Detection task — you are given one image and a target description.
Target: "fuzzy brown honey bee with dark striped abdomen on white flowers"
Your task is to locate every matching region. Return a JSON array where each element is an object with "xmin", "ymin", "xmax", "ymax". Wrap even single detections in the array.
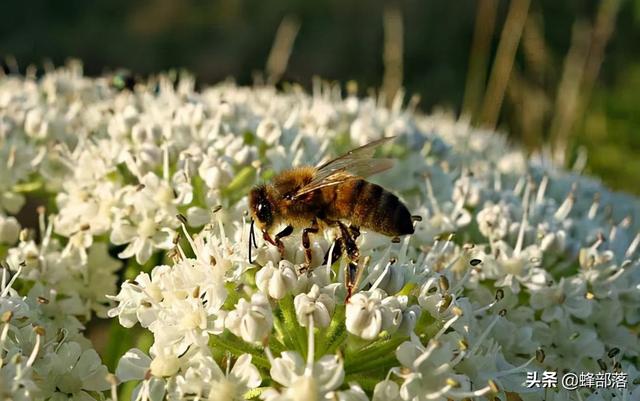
[{"xmin": 249, "ymin": 137, "xmax": 417, "ymax": 266}]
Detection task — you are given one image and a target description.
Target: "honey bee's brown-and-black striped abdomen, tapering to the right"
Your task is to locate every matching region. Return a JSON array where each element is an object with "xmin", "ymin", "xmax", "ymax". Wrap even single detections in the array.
[{"xmin": 323, "ymin": 179, "xmax": 413, "ymax": 237}]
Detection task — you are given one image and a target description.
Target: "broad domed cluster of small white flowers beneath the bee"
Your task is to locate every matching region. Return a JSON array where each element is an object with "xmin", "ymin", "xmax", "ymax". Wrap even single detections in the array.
[{"xmin": 0, "ymin": 64, "xmax": 640, "ymax": 401}]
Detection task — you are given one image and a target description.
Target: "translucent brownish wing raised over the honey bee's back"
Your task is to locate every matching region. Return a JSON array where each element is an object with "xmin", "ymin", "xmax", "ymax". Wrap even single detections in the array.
[{"xmin": 294, "ymin": 136, "xmax": 395, "ymax": 197}]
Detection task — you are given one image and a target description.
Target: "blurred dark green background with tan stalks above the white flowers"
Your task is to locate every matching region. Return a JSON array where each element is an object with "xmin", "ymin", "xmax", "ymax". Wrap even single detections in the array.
[{"xmin": 0, "ymin": 0, "xmax": 640, "ymax": 194}]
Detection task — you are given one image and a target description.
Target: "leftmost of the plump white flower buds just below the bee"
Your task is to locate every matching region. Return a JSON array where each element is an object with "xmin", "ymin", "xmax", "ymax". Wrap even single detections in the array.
[{"xmin": 225, "ymin": 293, "xmax": 273, "ymax": 342}]
